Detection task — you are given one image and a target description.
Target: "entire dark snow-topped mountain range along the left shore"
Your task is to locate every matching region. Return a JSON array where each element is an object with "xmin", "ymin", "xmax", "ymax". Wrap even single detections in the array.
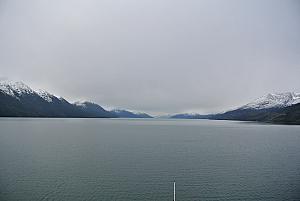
[{"xmin": 0, "ymin": 81, "xmax": 151, "ymax": 118}]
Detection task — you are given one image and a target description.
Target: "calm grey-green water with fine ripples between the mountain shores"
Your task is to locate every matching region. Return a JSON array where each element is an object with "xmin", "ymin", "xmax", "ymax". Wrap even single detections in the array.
[{"xmin": 0, "ymin": 118, "xmax": 300, "ymax": 201}]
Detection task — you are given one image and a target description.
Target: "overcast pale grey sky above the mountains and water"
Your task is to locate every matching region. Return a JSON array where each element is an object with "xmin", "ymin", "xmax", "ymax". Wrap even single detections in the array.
[{"xmin": 0, "ymin": 0, "xmax": 300, "ymax": 114}]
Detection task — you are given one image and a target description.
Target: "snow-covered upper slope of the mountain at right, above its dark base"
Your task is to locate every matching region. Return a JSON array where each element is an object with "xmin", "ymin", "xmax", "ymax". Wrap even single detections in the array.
[{"xmin": 240, "ymin": 92, "xmax": 300, "ymax": 110}]
